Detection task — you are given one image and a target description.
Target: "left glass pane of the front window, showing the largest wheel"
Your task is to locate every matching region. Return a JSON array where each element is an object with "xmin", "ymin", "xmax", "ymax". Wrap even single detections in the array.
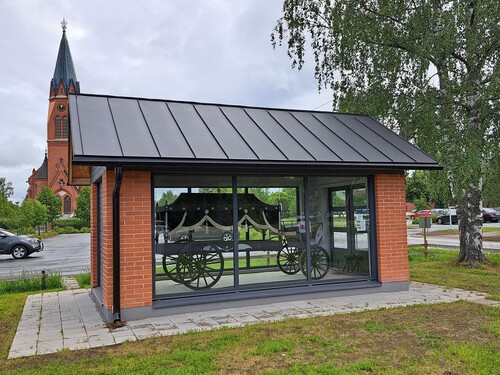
[{"xmin": 153, "ymin": 176, "xmax": 234, "ymax": 295}]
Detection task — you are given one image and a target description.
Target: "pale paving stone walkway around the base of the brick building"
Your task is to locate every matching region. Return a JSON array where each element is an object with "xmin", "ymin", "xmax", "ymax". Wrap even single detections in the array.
[{"xmin": 9, "ymin": 283, "xmax": 500, "ymax": 358}]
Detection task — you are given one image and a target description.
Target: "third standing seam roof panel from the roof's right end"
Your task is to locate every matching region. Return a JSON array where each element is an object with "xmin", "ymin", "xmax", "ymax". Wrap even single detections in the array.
[{"xmin": 314, "ymin": 113, "xmax": 392, "ymax": 163}]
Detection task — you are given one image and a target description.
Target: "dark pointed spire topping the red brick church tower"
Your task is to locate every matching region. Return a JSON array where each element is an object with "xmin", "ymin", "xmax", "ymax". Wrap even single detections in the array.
[{"xmin": 50, "ymin": 19, "xmax": 80, "ymax": 97}]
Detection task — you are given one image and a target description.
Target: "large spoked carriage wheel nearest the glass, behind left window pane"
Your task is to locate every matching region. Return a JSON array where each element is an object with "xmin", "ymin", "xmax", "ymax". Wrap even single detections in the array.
[{"xmin": 176, "ymin": 242, "xmax": 224, "ymax": 290}]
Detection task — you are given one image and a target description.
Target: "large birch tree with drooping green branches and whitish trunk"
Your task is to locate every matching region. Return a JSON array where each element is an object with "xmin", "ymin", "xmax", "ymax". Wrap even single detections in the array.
[{"xmin": 272, "ymin": 0, "xmax": 500, "ymax": 265}]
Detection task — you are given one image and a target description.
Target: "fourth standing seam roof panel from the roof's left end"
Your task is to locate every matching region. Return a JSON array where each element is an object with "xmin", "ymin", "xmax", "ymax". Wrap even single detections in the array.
[{"xmin": 168, "ymin": 103, "xmax": 227, "ymax": 159}]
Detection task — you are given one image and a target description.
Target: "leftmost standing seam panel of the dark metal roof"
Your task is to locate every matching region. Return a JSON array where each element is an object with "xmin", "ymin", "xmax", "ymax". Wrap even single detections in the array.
[{"xmin": 70, "ymin": 96, "xmax": 123, "ymax": 156}]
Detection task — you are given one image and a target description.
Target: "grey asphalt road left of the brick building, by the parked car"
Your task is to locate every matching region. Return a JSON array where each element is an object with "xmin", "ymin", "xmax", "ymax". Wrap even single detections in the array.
[{"xmin": 0, "ymin": 233, "xmax": 90, "ymax": 280}]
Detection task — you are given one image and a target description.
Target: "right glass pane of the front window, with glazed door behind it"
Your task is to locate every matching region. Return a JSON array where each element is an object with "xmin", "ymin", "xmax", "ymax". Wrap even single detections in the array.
[{"xmin": 309, "ymin": 177, "xmax": 370, "ymax": 280}]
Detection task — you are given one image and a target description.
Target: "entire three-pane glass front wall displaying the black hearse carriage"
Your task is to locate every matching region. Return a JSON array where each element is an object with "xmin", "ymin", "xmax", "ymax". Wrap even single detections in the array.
[{"xmin": 153, "ymin": 175, "xmax": 371, "ymax": 298}]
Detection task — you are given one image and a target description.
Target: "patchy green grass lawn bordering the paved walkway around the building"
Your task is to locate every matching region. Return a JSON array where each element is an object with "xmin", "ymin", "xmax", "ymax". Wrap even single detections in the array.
[{"xmin": 0, "ymin": 249, "xmax": 500, "ymax": 375}]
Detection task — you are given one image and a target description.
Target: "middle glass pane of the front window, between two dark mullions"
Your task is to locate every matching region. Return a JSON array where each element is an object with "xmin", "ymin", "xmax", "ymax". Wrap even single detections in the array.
[{"xmin": 238, "ymin": 177, "xmax": 306, "ymax": 286}]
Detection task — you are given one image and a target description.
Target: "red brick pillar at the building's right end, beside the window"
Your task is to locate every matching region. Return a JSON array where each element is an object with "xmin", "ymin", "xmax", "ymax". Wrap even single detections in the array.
[{"xmin": 375, "ymin": 174, "xmax": 409, "ymax": 282}]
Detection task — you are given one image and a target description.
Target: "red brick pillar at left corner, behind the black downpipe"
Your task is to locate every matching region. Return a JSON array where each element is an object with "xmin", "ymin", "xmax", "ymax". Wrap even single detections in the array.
[{"xmin": 91, "ymin": 169, "xmax": 153, "ymax": 313}]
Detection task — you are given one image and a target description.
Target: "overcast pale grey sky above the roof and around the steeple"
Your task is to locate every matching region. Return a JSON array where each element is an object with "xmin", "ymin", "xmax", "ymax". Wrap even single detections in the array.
[{"xmin": 0, "ymin": 0, "xmax": 331, "ymax": 201}]
